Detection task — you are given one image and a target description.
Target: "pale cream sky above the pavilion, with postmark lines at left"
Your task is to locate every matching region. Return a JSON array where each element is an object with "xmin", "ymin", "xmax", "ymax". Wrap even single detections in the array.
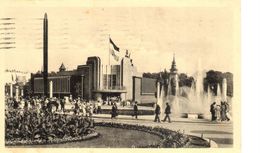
[{"xmin": 0, "ymin": 7, "xmax": 238, "ymax": 75}]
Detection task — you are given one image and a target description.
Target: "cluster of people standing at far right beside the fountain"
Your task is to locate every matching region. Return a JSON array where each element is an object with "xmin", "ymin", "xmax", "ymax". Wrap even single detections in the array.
[{"xmin": 210, "ymin": 101, "xmax": 230, "ymax": 122}]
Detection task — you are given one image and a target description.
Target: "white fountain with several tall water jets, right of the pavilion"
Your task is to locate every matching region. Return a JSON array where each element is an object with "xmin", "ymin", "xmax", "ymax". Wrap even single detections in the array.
[{"xmin": 157, "ymin": 57, "xmax": 232, "ymax": 119}]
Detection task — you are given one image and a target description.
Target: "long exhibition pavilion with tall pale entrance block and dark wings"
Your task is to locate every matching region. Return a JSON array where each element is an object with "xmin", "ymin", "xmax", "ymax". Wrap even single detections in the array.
[{"xmin": 31, "ymin": 57, "xmax": 156, "ymax": 103}]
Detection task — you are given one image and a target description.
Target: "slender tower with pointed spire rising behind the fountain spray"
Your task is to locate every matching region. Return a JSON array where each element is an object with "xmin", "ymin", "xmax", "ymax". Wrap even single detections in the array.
[{"xmin": 168, "ymin": 54, "xmax": 179, "ymax": 96}]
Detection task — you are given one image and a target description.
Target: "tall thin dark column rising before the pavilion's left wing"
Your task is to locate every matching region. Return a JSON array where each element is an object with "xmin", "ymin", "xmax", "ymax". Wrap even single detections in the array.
[{"xmin": 43, "ymin": 13, "xmax": 48, "ymax": 97}]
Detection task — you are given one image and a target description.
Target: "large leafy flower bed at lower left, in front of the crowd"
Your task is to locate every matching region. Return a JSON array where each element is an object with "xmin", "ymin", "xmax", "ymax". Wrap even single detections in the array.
[{"xmin": 5, "ymin": 109, "xmax": 99, "ymax": 146}]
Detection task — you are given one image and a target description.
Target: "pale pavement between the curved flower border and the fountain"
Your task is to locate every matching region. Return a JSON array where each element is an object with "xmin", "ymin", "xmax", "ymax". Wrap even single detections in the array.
[{"xmin": 93, "ymin": 114, "xmax": 233, "ymax": 148}]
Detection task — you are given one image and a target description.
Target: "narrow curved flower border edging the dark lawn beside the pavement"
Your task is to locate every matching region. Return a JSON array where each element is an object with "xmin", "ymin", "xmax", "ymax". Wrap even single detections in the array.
[{"xmin": 95, "ymin": 122, "xmax": 209, "ymax": 148}]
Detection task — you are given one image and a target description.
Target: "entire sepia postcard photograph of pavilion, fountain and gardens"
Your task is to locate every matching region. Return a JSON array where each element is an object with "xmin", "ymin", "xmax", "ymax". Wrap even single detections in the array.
[{"xmin": 0, "ymin": 1, "xmax": 240, "ymax": 151}]
